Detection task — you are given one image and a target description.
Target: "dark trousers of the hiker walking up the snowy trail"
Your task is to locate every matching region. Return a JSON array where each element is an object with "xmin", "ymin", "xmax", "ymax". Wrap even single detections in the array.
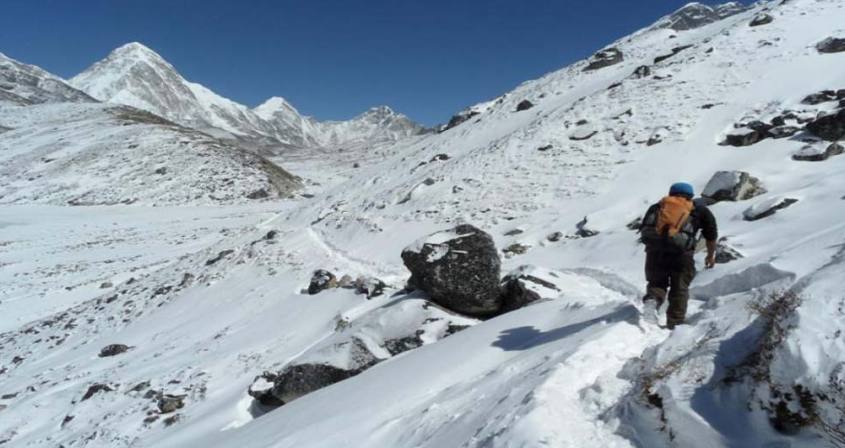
[{"xmin": 644, "ymin": 251, "xmax": 695, "ymax": 327}]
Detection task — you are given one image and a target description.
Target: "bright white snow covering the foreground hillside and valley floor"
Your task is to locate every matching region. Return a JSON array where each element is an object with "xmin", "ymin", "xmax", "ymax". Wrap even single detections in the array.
[{"xmin": 0, "ymin": 0, "xmax": 845, "ymax": 448}]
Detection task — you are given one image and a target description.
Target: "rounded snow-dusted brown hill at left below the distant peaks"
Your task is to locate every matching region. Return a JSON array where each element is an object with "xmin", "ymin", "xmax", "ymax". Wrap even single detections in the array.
[{"xmin": 0, "ymin": 103, "xmax": 299, "ymax": 205}]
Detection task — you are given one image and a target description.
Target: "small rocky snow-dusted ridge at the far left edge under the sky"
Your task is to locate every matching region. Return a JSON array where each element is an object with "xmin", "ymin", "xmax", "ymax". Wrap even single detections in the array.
[{"xmin": 0, "ymin": 53, "xmax": 94, "ymax": 105}]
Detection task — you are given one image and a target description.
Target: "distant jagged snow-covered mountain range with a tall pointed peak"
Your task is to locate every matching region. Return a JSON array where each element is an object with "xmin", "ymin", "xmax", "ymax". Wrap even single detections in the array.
[{"xmin": 70, "ymin": 42, "xmax": 422, "ymax": 147}]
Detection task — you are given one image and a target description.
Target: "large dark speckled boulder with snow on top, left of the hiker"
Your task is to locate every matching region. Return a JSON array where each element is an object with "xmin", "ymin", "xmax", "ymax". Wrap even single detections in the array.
[{"xmin": 402, "ymin": 224, "xmax": 502, "ymax": 317}]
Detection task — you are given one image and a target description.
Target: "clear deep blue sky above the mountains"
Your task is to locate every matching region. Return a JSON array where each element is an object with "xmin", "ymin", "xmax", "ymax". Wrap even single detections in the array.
[{"xmin": 0, "ymin": 0, "xmax": 732, "ymax": 125}]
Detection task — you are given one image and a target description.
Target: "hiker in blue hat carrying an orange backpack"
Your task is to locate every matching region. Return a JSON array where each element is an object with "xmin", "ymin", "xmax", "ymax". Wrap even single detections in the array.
[{"xmin": 640, "ymin": 182, "xmax": 719, "ymax": 330}]
